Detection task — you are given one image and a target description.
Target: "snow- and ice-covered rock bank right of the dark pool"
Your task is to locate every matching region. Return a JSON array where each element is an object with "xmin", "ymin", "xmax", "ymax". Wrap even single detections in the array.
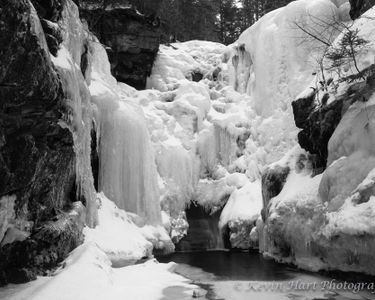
[{"xmin": 256, "ymin": 4, "xmax": 375, "ymax": 274}]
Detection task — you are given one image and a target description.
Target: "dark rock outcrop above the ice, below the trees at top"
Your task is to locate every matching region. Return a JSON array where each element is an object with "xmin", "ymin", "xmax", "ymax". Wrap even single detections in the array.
[{"xmin": 80, "ymin": 1, "xmax": 161, "ymax": 90}]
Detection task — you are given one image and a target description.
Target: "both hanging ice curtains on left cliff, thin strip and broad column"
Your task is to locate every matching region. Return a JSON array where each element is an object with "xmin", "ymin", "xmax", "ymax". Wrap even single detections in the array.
[{"xmin": 52, "ymin": 1, "xmax": 161, "ymax": 225}]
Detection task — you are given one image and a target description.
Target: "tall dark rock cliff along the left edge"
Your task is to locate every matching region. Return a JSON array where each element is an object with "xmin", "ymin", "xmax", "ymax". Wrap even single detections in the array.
[{"xmin": 0, "ymin": 0, "xmax": 89, "ymax": 285}]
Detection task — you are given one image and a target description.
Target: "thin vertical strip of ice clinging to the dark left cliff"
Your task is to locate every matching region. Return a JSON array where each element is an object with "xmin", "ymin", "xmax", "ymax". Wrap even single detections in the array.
[{"xmin": 51, "ymin": 1, "xmax": 97, "ymax": 226}]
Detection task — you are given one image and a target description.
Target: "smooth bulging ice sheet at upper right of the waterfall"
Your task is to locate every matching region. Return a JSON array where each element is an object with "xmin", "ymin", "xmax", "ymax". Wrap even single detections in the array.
[{"xmin": 228, "ymin": 0, "xmax": 350, "ymax": 117}]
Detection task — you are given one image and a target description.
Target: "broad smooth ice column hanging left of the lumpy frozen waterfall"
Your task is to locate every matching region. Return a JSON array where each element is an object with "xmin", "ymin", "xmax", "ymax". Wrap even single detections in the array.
[{"xmin": 90, "ymin": 42, "xmax": 161, "ymax": 225}]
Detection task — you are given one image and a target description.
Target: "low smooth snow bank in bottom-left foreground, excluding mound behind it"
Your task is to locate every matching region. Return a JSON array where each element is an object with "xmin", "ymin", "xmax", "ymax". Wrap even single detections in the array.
[{"xmin": 0, "ymin": 243, "xmax": 196, "ymax": 300}]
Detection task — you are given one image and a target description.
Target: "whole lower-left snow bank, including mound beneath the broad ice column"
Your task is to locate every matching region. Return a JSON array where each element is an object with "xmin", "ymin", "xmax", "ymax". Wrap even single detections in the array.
[{"xmin": 0, "ymin": 193, "xmax": 187, "ymax": 300}]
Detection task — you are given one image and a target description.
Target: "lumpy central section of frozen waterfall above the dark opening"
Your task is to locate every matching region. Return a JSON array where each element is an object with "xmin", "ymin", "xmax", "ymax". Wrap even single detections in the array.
[{"xmin": 145, "ymin": 41, "xmax": 272, "ymax": 231}]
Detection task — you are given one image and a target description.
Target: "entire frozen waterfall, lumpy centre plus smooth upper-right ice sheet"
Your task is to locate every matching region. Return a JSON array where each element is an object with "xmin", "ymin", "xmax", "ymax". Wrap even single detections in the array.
[{"xmin": 135, "ymin": 0, "xmax": 348, "ymax": 241}]
